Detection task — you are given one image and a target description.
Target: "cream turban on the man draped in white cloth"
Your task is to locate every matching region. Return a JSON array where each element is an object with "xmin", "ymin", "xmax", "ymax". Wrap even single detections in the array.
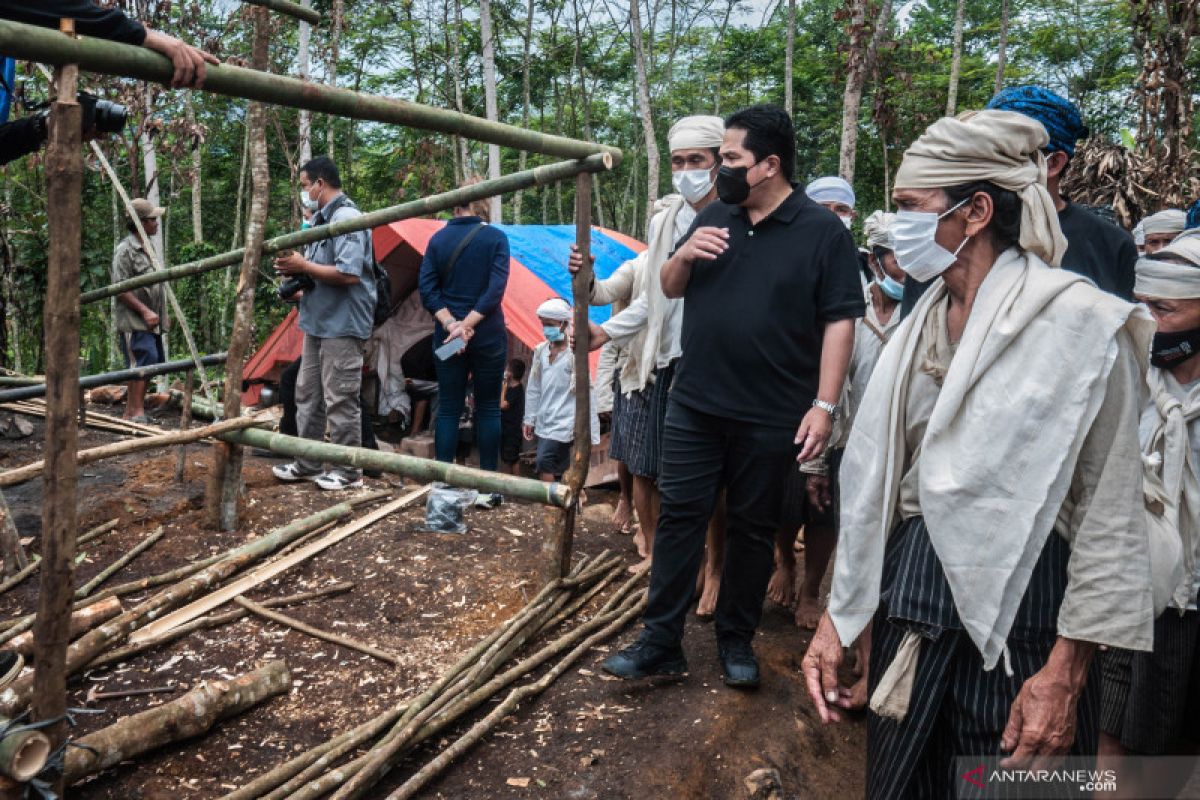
[{"xmin": 895, "ymin": 110, "xmax": 1067, "ymax": 266}]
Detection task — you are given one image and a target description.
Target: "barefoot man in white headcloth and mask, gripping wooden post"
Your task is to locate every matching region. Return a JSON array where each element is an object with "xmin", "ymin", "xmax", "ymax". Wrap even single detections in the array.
[{"xmin": 568, "ymin": 116, "xmax": 725, "ymax": 571}]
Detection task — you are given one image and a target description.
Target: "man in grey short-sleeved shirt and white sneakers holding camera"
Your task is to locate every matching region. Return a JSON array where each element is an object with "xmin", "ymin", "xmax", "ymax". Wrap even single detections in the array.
[{"xmin": 272, "ymin": 156, "xmax": 376, "ymax": 489}]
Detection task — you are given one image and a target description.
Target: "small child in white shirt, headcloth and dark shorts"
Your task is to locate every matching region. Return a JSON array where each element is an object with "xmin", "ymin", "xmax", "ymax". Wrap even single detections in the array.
[{"xmin": 522, "ymin": 297, "xmax": 600, "ymax": 481}]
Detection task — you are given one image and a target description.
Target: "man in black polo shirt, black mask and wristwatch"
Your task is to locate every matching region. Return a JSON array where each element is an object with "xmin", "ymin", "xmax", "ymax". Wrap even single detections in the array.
[{"xmin": 604, "ymin": 106, "xmax": 865, "ymax": 687}]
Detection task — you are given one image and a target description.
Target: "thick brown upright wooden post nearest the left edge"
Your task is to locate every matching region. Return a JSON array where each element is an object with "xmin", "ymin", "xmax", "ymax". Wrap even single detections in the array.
[{"xmin": 32, "ymin": 19, "xmax": 83, "ymax": 796}]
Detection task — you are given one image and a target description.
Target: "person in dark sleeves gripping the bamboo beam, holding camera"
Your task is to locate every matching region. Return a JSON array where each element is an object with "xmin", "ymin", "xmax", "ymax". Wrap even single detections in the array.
[{"xmin": 0, "ymin": 0, "xmax": 217, "ymax": 164}]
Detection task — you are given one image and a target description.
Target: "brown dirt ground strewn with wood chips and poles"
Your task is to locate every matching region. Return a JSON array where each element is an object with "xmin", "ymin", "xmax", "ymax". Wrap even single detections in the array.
[{"xmin": 0, "ymin": 408, "xmax": 865, "ymax": 800}]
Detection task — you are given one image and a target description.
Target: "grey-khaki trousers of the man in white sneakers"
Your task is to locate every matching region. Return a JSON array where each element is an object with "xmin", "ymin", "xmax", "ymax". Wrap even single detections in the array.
[{"xmin": 296, "ymin": 333, "xmax": 366, "ymax": 480}]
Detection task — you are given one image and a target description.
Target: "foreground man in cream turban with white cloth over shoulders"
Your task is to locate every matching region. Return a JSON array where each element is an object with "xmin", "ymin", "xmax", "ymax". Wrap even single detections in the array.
[{"xmin": 803, "ymin": 110, "xmax": 1153, "ymax": 798}]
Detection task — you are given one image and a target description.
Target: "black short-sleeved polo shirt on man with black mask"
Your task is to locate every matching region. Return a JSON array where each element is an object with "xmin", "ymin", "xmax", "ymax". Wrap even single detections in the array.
[{"xmin": 671, "ymin": 188, "xmax": 866, "ymax": 428}]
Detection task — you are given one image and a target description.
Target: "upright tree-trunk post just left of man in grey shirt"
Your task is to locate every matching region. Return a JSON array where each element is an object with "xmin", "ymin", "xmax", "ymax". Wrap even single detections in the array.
[{"xmin": 206, "ymin": 8, "xmax": 271, "ymax": 530}]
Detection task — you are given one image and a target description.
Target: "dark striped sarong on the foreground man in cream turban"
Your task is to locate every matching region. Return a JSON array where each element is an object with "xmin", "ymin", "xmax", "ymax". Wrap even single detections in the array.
[{"xmin": 866, "ymin": 517, "xmax": 1098, "ymax": 800}]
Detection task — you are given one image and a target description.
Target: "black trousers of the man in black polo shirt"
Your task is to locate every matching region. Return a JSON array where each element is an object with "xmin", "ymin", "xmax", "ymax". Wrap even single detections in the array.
[{"xmin": 642, "ymin": 398, "xmax": 797, "ymax": 645}]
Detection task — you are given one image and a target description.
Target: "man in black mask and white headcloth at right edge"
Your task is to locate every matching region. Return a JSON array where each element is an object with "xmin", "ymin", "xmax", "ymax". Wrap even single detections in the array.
[{"xmin": 1100, "ymin": 230, "xmax": 1200, "ymax": 798}]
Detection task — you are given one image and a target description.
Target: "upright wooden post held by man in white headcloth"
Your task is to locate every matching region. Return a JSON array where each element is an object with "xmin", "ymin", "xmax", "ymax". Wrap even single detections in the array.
[{"xmin": 544, "ymin": 173, "xmax": 592, "ymax": 579}]
